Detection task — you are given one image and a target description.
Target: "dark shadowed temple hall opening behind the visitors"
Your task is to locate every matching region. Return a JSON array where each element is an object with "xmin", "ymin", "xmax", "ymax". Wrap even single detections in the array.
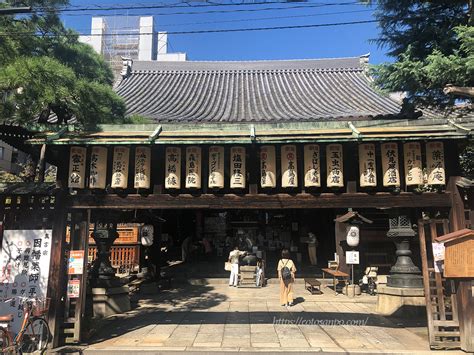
[{"xmin": 156, "ymin": 209, "xmax": 395, "ymax": 278}]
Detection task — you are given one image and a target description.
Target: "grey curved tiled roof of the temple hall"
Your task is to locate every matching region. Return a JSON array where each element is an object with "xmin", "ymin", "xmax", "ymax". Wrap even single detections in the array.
[{"xmin": 116, "ymin": 57, "xmax": 408, "ymax": 123}]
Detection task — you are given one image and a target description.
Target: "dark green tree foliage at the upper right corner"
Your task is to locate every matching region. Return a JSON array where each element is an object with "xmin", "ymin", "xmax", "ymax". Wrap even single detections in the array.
[{"xmin": 372, "ymin": 0, "xmax": 474, "ymax": 108}]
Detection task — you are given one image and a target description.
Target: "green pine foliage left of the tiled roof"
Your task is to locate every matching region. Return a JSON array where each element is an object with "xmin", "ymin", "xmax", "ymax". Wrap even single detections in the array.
[{"xmin": 0, "ymin": 0, "xmax": 125, "ymax": 127}]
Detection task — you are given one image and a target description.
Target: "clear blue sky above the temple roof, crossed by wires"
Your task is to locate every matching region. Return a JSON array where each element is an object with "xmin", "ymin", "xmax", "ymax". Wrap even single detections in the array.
[{"xmin": 62, "ymin": 0, "xmax": 390, "ymax": 64}]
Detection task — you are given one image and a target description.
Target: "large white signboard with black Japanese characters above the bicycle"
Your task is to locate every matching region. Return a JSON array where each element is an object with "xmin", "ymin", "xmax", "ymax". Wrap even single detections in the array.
[{"xmin": 0, "ymin": 230, "xmax": 52, "ymax": 333}]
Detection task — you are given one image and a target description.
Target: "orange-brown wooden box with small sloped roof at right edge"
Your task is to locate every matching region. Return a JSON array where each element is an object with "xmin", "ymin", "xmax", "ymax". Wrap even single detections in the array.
[{"xmin": 435, "ymin": 229, "xmax": 474, "ymax": 278}]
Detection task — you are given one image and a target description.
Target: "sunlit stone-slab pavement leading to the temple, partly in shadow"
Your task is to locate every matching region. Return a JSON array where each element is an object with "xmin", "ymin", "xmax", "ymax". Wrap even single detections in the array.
[{"xmin": 78, "ymin": 284, "xmax": 453, "ymax": 355}]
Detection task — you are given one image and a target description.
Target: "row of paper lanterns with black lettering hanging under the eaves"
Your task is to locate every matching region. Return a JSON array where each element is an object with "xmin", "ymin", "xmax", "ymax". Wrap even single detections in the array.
[{"xmin": 69, "ymin": 142, "xmax": 446, "ymax": 189}]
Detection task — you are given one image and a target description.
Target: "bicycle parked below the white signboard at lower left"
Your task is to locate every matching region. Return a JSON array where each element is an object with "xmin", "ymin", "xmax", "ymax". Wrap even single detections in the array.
[{"xmin": 0, "ymin": 297, "xmax": 50, "ymax": 354}]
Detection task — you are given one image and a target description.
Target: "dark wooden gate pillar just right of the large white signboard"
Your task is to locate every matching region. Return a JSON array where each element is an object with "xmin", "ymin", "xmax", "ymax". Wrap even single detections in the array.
[{"xmin": 47, "ymin": 192, "xmax": 67, "ymax": 348}]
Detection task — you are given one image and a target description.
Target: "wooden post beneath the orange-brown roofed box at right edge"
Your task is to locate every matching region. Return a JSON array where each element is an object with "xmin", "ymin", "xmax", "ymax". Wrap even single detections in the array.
[{"xmin": 456, "ymin": 279, "xmax": 474, "ymax": 353}]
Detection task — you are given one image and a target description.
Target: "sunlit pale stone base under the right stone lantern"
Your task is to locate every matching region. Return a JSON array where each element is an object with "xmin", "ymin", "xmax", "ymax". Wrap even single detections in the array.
[{"xmin": 375, "ymin": 285, "xmax": 426, "ymax": 317}]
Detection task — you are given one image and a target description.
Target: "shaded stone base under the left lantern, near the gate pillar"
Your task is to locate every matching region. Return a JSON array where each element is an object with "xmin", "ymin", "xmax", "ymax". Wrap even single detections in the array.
[{"xmin": 92, "ymin": 286, "xmax": 131, "ymax": 318}]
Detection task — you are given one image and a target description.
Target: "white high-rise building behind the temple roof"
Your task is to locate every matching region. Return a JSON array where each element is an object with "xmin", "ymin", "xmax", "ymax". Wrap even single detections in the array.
[{"xmin": 79, "ymin": 16, "xmax": 186, "ymax": 73}]
